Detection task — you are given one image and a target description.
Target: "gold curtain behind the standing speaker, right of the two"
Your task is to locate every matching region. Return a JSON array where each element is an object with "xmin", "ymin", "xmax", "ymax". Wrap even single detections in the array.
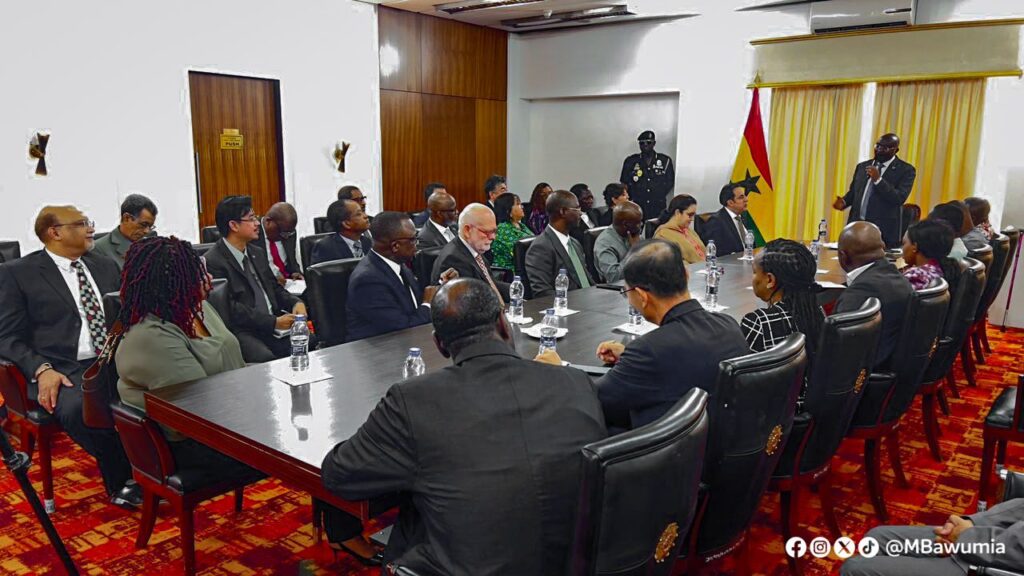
[{"xmin": 873, "ymin": 78, "xmax": 986, "ymax": 215}]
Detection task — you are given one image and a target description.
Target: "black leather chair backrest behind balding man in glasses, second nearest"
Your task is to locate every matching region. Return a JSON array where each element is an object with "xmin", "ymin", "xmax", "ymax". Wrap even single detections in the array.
[{"xmin": 694, "ymin": 332, "xmax": 807, "ymax": 554}]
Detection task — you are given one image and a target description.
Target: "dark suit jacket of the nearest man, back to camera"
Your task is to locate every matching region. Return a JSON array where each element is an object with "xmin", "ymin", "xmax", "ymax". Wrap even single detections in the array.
[{"xmin": 322, "ymin": 340, "xmax": 606, "ymax": 576}]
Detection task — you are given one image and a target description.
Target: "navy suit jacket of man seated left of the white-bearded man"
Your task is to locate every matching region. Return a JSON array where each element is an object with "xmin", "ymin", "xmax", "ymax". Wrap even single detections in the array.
[{"xmin": 345, "ymin": 252, "xmax": 430, "ymax": 342}]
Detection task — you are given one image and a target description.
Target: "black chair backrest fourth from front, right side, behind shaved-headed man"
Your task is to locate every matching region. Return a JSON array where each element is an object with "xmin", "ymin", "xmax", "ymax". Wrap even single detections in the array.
[{"xmin": 881, "ymin": 279, "xmax": 950, "ymax": 422}]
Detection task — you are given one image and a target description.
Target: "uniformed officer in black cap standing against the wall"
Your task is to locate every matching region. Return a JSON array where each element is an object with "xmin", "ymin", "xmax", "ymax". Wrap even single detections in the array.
[{"xmin": 618, "ymin": 130, "xmax": 676, "ymax": 219}]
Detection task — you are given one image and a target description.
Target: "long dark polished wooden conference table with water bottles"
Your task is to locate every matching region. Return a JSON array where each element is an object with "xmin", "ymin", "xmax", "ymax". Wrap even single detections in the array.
[{"xmin": 145, "ymin": 250, "xmax": 846, "ymax": 520}]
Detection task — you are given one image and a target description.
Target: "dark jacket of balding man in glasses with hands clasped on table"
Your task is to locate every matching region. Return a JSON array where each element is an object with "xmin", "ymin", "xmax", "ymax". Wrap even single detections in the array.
[{"xmin": 597, "ymin": 299, "xmax": 751, "ymax": 427}]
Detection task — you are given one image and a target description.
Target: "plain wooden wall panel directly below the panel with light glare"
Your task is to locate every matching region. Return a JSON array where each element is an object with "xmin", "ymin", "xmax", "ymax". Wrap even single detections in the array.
[{"xmin": 381, "ymin": 90, "xmax": 425, "ymax": 210}]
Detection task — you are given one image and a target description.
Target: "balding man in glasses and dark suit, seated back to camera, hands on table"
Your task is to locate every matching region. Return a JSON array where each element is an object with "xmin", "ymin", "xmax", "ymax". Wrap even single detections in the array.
[{"xmin": 539, "ymin": 240, "xmax": 751, "ymax": 428}]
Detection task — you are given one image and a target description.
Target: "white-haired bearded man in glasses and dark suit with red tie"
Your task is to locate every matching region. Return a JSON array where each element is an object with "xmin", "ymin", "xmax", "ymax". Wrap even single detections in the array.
[{"xmin": 430, "ymin": 202, "xmax": 509, "ymax": 304}]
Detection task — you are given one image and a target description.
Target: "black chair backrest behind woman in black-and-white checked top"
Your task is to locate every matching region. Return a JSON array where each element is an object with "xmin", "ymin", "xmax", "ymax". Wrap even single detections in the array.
[{"xmin": 794, "ymin": 298, "xmax": 882, "ymax": 474}]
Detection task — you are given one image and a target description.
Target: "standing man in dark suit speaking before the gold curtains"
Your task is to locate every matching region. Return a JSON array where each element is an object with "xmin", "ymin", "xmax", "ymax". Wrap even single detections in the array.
[{"xmin": 833, "ymin": 134, "xmax": 918, "ymax": 248}]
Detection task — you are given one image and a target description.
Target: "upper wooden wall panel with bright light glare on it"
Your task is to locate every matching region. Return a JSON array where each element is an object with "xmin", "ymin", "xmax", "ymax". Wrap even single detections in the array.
[{"xmin": 377, "ymin": 6, "xmax": 423, "ymax": 92}]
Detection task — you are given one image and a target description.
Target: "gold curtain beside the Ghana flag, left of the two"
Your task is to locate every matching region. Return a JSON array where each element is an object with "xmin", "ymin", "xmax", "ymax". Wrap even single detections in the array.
[{"xmin": 766, "ymin": 84, "xmax": 864, "ymax": 241}]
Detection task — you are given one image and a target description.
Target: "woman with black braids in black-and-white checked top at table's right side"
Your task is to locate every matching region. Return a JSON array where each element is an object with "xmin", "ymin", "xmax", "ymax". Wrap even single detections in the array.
[{"xmin": 740, "ymin": 239, "xmax": 824, "ymax": 359}]
